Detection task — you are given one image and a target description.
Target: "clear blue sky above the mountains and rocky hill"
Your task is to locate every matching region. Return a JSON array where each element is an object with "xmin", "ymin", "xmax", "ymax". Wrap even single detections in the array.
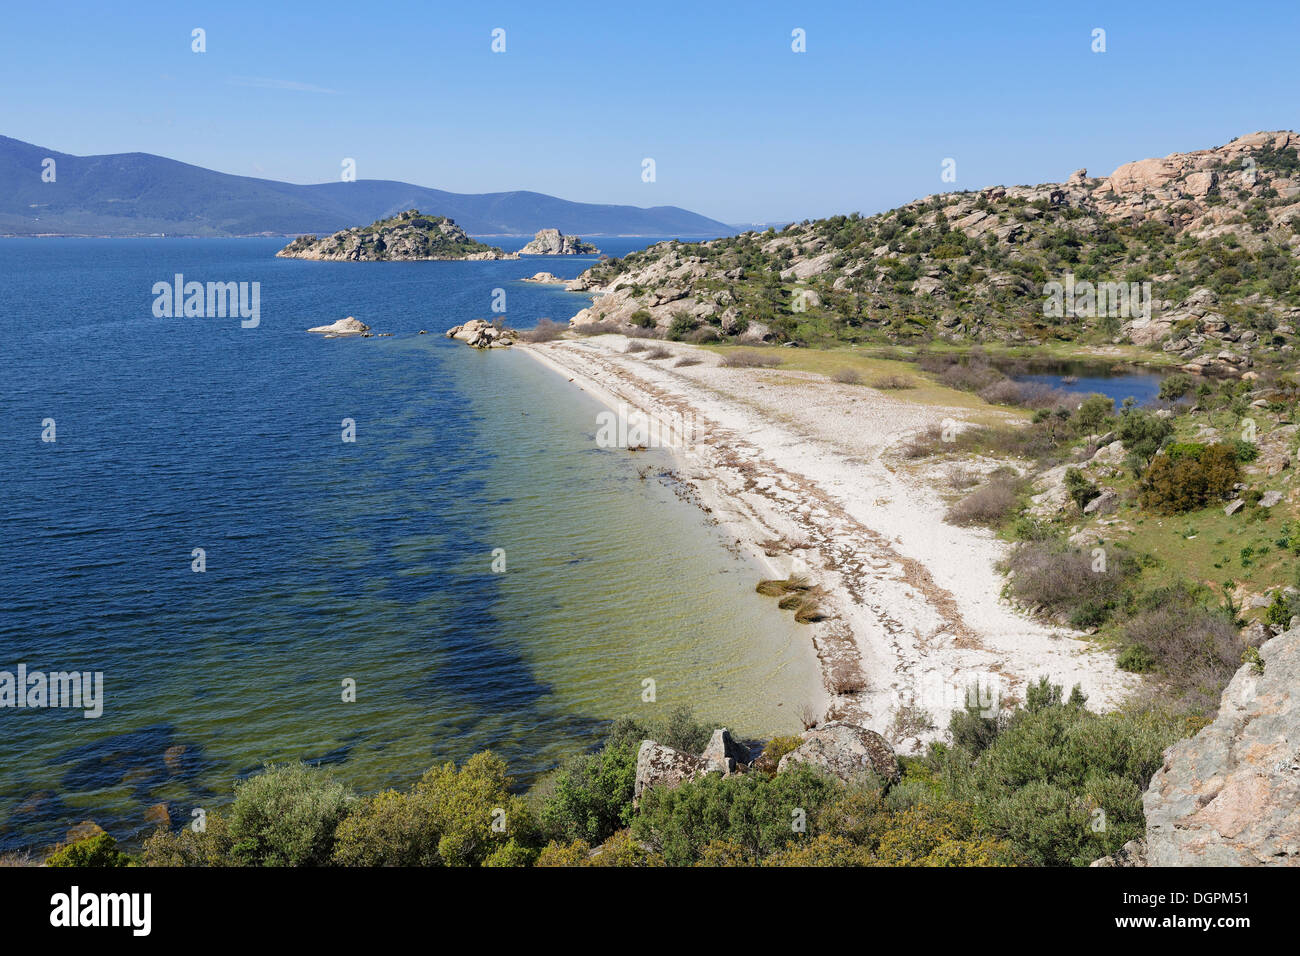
[{"xmin": 0, "ymin": 0, "xmax": 1300, "ymax": 222}]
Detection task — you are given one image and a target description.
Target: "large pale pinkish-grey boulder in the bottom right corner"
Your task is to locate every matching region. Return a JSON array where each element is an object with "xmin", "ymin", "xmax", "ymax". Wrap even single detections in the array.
[{"xmin": 1143, "ymin": 628, "xmax": 1300, "ymax": 866}]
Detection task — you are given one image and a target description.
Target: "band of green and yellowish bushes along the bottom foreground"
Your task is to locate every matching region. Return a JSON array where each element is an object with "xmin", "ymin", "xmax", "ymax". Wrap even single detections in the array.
[{"xmin": 40, "ymin": 679, "xmax": 1183, "ymax": 866}]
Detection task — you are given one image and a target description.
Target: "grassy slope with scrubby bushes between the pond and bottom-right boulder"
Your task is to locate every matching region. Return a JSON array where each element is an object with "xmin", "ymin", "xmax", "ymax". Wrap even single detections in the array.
[{"xmin": 898, "ymin": 356, "xmax": 1300, "ymax": 728}]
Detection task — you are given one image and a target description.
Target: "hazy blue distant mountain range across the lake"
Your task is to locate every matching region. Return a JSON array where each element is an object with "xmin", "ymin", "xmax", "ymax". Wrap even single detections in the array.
[{"xmin": 0, "ymin": 137, "xmax": 736, "ymax": 238}]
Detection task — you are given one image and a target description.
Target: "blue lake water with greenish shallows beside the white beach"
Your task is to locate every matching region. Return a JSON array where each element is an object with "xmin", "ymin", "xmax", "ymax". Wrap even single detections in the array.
[{"xmin": 0, "ymin": 239, "xmax": 811, "ymax": 849}]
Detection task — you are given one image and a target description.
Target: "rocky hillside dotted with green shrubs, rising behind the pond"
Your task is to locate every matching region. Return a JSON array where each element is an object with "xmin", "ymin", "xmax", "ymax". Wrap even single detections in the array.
[{"xmin": 568, "ymin": 131, "xmax": 1300, "ymax": 373}]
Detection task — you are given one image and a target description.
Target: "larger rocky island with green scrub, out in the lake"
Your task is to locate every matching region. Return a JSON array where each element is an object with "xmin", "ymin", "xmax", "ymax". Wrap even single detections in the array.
[{"xmin": 276, "ymin": 209, "xmax": 519, "ymax": 263}]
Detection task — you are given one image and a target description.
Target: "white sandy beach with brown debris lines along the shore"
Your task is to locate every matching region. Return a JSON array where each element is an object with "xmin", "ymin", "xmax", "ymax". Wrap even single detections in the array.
[{"xmin": 520, "ymin": 336, "xmax": 1135, "ymax": 749}]
